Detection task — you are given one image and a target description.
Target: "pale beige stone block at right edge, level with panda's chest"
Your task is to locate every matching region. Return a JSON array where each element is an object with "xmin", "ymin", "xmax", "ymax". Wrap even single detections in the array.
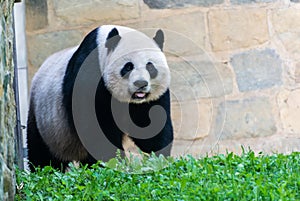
[{"xmin": 278, "ymin": 90, "xmax": 300, "ymax": 134}]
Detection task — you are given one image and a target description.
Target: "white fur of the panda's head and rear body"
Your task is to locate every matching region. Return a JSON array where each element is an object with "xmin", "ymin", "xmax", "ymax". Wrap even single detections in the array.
[{"xmin": 30, "ymin": 25, "xmax": 170, "ymax": 170}]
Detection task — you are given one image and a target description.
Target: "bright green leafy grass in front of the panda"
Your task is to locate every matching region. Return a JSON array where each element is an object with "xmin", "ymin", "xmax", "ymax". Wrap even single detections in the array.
[{"xmin": 16, "ymin": 151, "xmax": 300, "ymax": 201}]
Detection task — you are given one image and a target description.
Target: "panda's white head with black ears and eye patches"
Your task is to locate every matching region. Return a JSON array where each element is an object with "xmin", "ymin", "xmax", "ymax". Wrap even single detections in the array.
[{"xmin": 102, "ymin": 27, "xmax": 170, "ymax": 103}]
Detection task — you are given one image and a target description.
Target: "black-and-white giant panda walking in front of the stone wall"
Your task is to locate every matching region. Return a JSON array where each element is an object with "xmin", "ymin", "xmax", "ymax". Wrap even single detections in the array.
[{"xmin": 27, "ymin": 25, "xmax": 173, "ymax": 170}]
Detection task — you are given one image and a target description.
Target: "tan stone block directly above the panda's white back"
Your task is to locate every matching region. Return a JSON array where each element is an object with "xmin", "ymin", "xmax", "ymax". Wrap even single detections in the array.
[{"xmin": 27, "ymin": 30, "xmax": 84, "ymax": 78}]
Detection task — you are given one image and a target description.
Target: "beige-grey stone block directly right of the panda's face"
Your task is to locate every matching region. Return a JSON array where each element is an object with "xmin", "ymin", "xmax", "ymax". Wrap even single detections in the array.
[{"xmin": 168, "ymin": 60, "xmax": 233, "ymax": 101}]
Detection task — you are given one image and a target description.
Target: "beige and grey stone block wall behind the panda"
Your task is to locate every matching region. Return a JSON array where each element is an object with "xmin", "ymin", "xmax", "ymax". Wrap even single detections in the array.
[{"xmin": 26, "ymin": 0, "xmax": 300, "ymax": 155}]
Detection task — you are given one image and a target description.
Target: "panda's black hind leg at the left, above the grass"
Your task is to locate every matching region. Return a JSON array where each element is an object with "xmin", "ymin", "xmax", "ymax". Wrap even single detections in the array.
[{"xmin": 27, "ymin": 104, "xmax": 68, "ymax": 171}]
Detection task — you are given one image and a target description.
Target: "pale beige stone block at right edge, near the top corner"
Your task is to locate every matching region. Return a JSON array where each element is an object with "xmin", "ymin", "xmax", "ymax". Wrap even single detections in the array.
[{"xmin": 271, "ymin": 7, "xmax": 300, "ymax": 33}]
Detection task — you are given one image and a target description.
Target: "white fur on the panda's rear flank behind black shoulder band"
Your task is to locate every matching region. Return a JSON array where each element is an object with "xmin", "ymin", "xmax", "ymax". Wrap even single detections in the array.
[{"xmin": 31, "ymin": 47, "xmax": 85, "ymax": 159}]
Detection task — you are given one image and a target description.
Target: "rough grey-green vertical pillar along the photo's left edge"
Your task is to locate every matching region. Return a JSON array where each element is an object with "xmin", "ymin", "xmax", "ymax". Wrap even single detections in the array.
[{"xmin": 0, "ymin": 0, "xmax": 16, "ymax": 200}]
